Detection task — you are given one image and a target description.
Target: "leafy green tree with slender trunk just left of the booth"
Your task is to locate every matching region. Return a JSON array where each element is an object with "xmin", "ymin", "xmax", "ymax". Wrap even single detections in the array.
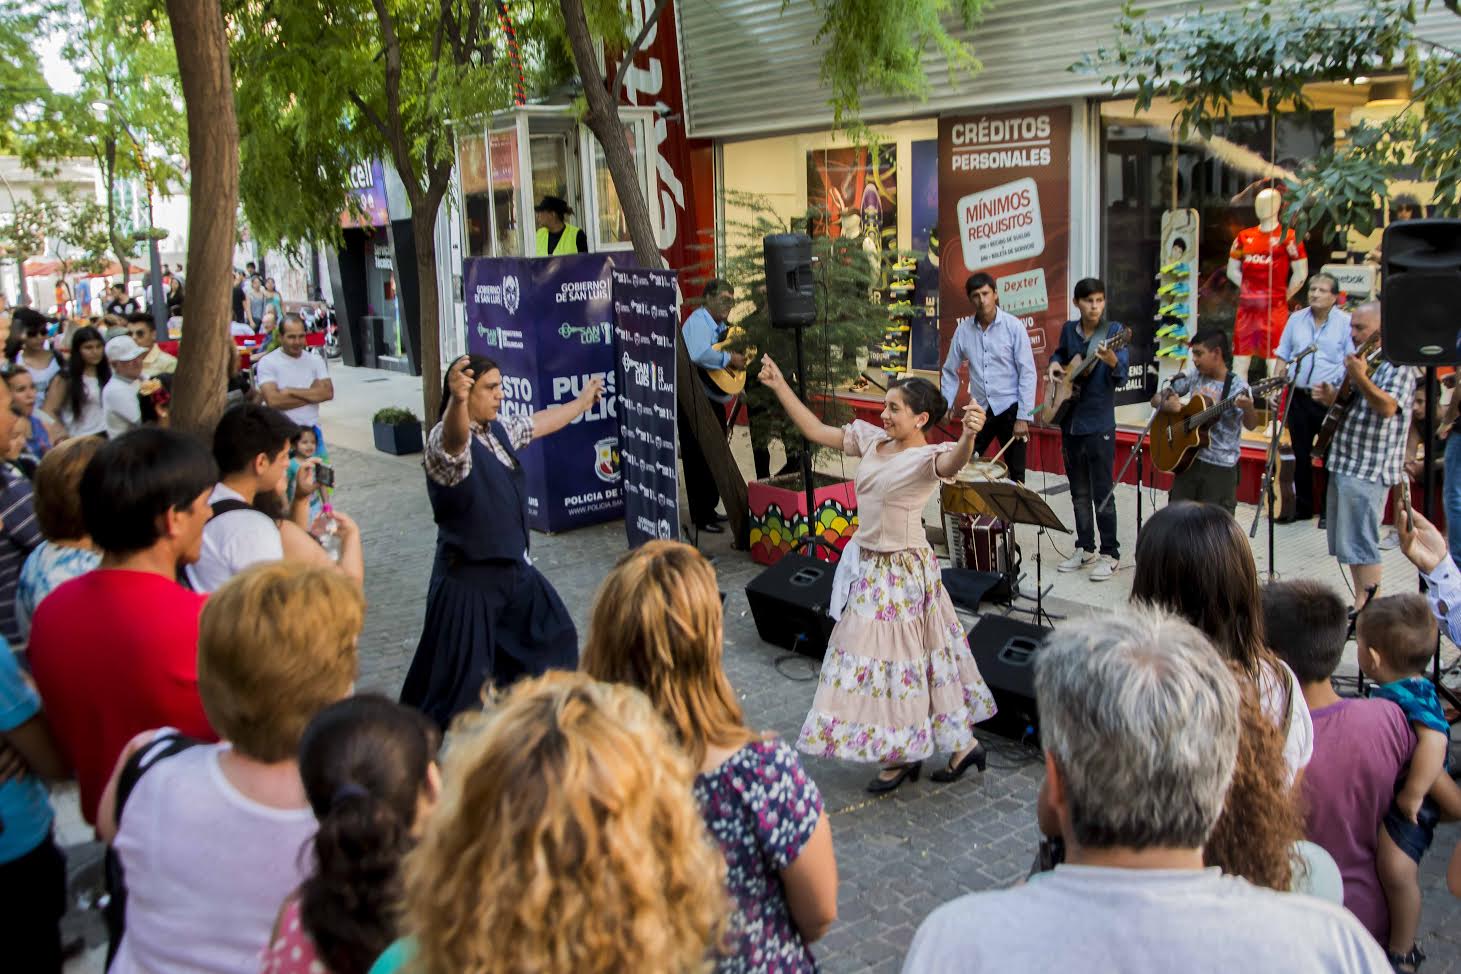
[{"xmin": 228, "ymin": 0, "xmax": 578, "ymax": 415}]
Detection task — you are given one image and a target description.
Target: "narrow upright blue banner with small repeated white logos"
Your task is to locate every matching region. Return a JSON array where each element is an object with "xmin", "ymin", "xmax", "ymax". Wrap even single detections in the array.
[{"xmin": 614, "ymin": 267, "xmax": 679, "ymax": 548}]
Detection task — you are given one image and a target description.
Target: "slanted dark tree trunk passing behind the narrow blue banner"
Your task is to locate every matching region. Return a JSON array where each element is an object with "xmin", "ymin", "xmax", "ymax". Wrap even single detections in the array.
[{"xmin": 560, "ymin": 0, "xmax": 751, "ymax": 549}]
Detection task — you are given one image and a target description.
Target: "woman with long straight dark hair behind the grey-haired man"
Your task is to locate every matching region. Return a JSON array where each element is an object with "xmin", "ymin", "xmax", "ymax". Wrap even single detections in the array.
[{"xmin": 1131, "ymin": 501, "xmax": 1313, "ymax": 784}]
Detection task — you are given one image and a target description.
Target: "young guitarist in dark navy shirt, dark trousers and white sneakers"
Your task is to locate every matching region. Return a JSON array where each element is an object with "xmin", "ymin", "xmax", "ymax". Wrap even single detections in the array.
[{"xmin": 1045, "ymin": 277, "xmax": 1126, "ymax": 581}]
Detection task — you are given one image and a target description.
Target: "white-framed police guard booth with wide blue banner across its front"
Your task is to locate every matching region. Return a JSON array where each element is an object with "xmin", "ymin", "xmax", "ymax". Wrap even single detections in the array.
[{"xmin": 443, "ymin": 105, "xmax": 678, "ymax": 532}]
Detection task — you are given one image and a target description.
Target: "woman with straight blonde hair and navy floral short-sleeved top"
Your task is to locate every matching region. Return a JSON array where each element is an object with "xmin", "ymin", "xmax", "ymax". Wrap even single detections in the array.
[{"xmin": 581, "ymin": 542, "xmax": 837, "ymax": 974}]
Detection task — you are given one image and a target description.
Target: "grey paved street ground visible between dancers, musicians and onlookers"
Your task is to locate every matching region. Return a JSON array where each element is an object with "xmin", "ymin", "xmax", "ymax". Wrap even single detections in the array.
[{"xmin": 63, "ymin": 367, "xmax": 1461, "ymax": 974}]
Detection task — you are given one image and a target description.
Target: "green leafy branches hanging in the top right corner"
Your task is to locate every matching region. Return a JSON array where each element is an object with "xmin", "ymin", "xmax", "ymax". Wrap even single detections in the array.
[{"xmin": 1072, "ymin": 0, "xmax": 1461, "ymax": 235}]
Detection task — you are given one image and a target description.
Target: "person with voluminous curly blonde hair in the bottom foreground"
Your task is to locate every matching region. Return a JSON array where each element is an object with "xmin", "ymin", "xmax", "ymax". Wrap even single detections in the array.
[{"xmin": 371, "ymin": 672, "xmax": 729, "ymax": 974}]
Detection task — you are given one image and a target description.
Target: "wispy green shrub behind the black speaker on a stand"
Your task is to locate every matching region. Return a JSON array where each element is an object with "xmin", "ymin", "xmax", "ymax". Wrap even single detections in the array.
[{"xmin": 723, "ymin": 193, "xmax": 888, "ymax": 467}]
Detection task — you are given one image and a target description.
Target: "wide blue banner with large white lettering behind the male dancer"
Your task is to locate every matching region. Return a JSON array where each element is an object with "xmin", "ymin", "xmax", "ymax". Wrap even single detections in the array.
[{"xmin": 462, "ymin": 254, "xmax": 624, "ymax": 532}]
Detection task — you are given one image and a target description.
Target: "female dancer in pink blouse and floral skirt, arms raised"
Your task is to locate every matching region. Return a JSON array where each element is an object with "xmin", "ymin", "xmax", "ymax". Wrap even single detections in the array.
[{"xmin": 761, "ymin": 356, "xmax": 995, "ymax": 791}]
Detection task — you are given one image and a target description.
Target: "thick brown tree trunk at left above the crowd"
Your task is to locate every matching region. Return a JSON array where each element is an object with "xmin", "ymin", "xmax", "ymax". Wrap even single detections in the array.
[{"xmin": 168, "ymin": 0, "xmax": 238, "ymax": 437}]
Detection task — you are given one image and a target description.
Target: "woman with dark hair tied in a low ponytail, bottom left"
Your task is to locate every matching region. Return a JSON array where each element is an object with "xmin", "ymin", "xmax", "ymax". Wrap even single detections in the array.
[{"xmin": 263, "ymin": 694, "xmax": 441, "ymax": 974}]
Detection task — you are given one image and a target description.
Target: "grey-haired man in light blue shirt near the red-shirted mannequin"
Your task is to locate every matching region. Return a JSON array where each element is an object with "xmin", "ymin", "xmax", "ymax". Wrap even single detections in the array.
[{"xmin": 1274, "ymin": 272, "xmax": 1354, "ymax": 521}]
